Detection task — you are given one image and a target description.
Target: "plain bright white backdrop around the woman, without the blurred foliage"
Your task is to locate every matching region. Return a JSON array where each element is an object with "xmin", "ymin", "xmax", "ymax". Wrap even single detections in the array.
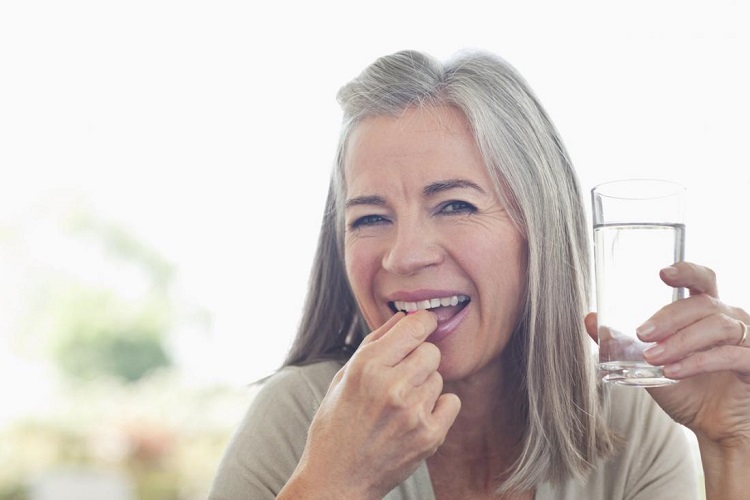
[{"xmin": 0, "ymin": 0, "xmax": 750, "ymax": 394}]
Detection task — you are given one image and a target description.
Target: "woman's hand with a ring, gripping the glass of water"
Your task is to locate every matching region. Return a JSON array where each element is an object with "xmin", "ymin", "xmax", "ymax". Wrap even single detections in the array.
[{"xmin": 586, "ymin": 262, "xmax": 750, "ymax": 451}]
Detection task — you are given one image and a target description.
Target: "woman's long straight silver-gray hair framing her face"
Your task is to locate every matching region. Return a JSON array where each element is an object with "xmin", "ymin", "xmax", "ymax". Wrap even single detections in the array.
[{"xmin": 285, "ymin": 51, "xmax": 612, "ymax": 492}]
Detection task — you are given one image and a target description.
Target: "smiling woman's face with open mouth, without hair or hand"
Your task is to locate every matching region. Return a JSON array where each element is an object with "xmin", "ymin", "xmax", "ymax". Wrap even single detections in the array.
[{"xmin": 345, "ymin": 107, "xmax": 526, "ymax": 380}]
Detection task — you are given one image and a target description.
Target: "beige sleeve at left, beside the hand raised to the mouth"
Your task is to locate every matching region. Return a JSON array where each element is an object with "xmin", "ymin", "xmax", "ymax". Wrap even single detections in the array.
[{"xmin": 208, "ymin": 363, "xmax": 340, "ymax": 500}]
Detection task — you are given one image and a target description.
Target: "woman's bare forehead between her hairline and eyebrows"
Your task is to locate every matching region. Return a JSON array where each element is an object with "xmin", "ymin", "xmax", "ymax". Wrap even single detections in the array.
[{"xmin": 344, "ymin": 106, "xmax": 488, "ymax": 191}]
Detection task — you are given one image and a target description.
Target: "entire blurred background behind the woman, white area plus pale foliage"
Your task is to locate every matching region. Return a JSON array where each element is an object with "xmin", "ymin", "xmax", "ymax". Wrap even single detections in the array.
[{"xmin": 0, "ymin": 0, "xmax": 750, "ymax": 499}]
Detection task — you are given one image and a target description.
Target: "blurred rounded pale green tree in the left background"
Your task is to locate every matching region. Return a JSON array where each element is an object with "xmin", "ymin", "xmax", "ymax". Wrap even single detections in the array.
[{"xmin": 6, "ymin": 202, "xmax": 177, "ymax": 382}]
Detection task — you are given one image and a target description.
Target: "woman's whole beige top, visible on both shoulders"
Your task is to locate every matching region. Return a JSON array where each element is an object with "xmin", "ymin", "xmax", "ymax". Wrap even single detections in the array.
[{"xmin": 209, "ymin": 361, "xmax": 699, "ymax": 500}]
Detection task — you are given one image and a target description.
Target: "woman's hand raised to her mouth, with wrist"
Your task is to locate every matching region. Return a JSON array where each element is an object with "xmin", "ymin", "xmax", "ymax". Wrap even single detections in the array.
[{"xmin": 278, "ymin": 311, "xmax": 461, "ymax": 499}]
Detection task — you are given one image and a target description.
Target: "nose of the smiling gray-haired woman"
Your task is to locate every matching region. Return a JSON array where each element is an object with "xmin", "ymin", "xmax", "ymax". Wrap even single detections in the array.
[{"xmin": 383, "ymin": 221, "xmax": 444, "ymax": 276}]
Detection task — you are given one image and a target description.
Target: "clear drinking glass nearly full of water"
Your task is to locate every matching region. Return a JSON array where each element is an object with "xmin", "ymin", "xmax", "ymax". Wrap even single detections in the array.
[{"xmin": 591, "ymin": 179, "xmax": 685, "ymax": 387}]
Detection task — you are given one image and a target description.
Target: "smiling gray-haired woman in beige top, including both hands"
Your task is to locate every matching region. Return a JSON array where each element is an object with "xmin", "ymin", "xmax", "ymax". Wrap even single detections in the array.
[{"xmin": 211, "ymin": 52, "xmax": 750, "ymax": 499}]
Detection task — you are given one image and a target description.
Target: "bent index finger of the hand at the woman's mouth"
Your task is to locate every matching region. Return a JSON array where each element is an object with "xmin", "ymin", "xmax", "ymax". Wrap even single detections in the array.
[{"xmin": 370, "ymin": 310, "xmax": 437, "ymax": 366}]
